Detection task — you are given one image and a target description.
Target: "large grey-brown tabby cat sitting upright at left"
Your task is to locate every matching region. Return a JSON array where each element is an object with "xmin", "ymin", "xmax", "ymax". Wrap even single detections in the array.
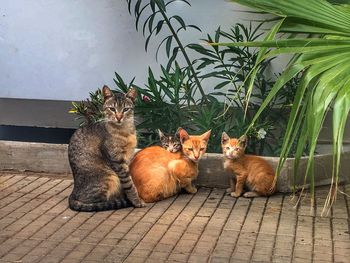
[{"xmin": 68, "ymin": 86, "xmax": 144, "ymax": 211}]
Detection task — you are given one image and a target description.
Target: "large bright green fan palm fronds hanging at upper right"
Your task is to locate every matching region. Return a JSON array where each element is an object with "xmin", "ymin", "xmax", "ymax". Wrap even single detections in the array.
[{"xmin": 212, "ymin": 0, "xmax": 350, "ymax": 213}]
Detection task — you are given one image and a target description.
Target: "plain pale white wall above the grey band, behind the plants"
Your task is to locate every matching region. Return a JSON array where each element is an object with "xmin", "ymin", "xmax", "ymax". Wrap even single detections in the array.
[{"xmin": 0, "ymin": 0, "xmax": 282, "ymax": 100}]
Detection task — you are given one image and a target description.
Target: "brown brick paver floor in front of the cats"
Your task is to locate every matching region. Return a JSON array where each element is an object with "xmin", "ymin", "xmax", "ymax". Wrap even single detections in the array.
[{"xmin": 0, "ymin": 172, "xmax": 350, "ymax": 263}]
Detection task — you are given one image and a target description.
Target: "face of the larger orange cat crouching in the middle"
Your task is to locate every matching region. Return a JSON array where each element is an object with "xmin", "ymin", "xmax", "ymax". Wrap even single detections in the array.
[{"xmin": 179, "ymin": 128, "xmax": 211, "ymax": 162}]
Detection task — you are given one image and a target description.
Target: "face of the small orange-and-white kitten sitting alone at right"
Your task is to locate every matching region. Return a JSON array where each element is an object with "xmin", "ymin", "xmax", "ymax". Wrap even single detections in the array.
[{"xmin": 221, "ymin": 132, "xmax": 248, "ymax": 159}]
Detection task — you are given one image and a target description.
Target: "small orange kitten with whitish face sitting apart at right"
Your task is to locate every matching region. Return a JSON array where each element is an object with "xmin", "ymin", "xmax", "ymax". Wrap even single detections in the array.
[{"xmin": 221, "ymin": 132, "xmax": 275, "ymax": 197}]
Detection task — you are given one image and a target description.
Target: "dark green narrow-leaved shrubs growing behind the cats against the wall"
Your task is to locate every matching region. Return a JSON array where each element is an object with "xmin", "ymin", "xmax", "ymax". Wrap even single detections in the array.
[{"xmin": 72, "ymin": 0, "xmax": 304, "ymax": 159}]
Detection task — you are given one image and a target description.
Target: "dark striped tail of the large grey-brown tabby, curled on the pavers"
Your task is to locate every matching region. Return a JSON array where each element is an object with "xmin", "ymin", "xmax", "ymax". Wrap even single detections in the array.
[{"xmin": 68, "ymin": 195, "xmax": 132, "ymax": 212}]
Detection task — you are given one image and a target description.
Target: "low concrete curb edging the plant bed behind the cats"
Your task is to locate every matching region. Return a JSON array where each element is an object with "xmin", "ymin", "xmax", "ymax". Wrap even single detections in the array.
[{"xmin": 0, "ymin": 141, "xmax": 350, "ymax": 192}]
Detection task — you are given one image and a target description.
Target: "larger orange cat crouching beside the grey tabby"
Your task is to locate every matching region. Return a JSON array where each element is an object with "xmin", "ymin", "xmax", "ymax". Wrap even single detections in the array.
[{"xmin": 130, "ymin": 128, "xmax": 210, "ymax": 202}]
